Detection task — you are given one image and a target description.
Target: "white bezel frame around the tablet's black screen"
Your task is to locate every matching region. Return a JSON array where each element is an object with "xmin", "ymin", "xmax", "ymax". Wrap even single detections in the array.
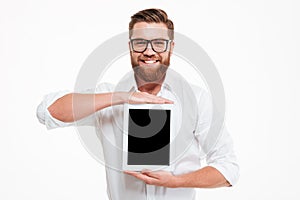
[{"xmin": 122, "ymin": 104, "xmax": 174, "ymax": 171}]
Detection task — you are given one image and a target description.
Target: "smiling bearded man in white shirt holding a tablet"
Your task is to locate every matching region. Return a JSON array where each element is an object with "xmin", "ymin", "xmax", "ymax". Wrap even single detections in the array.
[{"xmin": 37, "ymin": 9, "xmax": 239, "ymax": 200}]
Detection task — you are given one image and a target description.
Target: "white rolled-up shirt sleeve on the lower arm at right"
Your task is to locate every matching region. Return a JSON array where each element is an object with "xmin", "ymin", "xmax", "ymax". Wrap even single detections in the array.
[{"xmin": 195, "ymin": 88, "xmax": 239, "ymax": 185}]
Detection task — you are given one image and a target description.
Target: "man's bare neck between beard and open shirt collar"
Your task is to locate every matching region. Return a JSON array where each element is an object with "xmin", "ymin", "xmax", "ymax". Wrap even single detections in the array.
[{"xmin": 135, "ymin": 76, "xmax": 165, "ymax": 95}]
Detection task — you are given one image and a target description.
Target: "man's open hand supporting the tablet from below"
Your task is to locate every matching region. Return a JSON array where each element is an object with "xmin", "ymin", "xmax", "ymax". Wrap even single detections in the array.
[{"xmin": 124, "ymin": 170, "xmax": 179, "ymax": 188}]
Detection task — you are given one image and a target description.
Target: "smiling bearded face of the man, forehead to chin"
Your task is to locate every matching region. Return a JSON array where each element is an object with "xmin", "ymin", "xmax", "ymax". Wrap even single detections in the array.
[{"xmin": 129, "ymin": 22, "xmax": 174, "ymax": 82}]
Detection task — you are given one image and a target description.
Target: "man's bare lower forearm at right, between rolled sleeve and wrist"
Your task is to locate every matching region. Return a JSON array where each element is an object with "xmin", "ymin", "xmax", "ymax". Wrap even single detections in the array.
[{"xmin": 175, "ymin": 166, "xmax": 230, "ymax": 188}]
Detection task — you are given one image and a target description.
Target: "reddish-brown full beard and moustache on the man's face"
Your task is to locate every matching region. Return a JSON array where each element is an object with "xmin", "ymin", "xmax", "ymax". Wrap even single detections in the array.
[{"xmin": 131, "ymin": 54, "xmax": 170, "ymax": 83}]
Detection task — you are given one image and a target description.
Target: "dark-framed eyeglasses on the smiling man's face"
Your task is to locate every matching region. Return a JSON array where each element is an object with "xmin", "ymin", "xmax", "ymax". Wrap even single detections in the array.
[{"xmin": 130, "ymin": 39, "xmax": 172, "ymax": 53}]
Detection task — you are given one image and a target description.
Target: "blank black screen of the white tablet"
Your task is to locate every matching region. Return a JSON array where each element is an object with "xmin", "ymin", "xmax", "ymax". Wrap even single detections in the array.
[{"xmin": 127, "ymin": 108, "xmax": 171, "ymax": 165}]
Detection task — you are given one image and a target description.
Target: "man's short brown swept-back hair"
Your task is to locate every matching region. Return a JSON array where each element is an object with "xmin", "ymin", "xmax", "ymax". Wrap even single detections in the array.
[{"xmin": 129, "ymin": 8, "xmax": 174, "ymax": 40}]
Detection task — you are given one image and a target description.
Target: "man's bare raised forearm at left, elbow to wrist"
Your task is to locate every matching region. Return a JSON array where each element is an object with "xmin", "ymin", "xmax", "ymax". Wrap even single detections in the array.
[{"xmin": 48, "ymin": 92, "xmax": 128, "ymax": 122}]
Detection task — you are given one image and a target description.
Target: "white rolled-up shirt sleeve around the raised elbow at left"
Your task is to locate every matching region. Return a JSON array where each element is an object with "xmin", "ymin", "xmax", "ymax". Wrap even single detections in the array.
[{"xmin": 36, "ymin": 83, "xmax": 113, "ymax": 129}]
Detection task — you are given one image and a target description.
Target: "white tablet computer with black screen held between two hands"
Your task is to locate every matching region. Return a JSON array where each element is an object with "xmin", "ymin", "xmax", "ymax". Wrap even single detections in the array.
[{"xmin": 123, "ymin": 104, "xmax": 173, "ymax": 171}]
